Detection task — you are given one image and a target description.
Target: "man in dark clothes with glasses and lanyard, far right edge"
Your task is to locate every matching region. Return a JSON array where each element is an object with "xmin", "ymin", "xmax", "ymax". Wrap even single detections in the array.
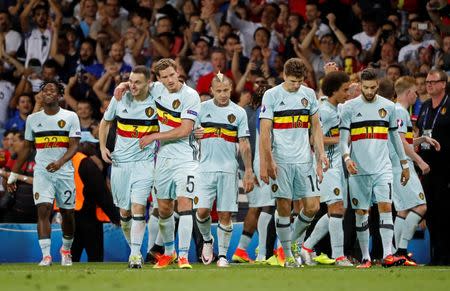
[{"xmin": 417, "ymin": 70, "xmax": 450, "ymax": 265}]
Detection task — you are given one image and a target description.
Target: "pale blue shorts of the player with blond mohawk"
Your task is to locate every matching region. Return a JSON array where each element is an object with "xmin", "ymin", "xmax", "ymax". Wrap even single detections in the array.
[{"xmin": 194, "ymin": 172, "xmax": 239, "ymax": 212}]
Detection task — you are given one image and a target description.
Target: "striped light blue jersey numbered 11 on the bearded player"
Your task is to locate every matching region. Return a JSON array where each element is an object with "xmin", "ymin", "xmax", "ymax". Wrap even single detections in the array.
[{"xmin": 339, "ymin": 95, "xmax": 397, "ymax": 175}]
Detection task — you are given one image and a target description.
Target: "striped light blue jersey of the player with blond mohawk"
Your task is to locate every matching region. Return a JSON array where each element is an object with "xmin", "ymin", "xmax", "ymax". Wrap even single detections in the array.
[{"xmin": 199, "ymin": 100, "xmax": 250, "ymax": 173}]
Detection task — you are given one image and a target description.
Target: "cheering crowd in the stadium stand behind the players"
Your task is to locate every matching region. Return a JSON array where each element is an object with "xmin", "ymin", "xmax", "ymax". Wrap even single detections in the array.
[{"xmin": 0, "ymin": 0, "xmax": 450, "ymax": 264}]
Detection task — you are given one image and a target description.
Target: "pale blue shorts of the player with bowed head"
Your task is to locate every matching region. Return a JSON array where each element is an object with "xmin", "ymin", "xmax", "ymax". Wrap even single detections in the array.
[{"xmin": 270, "ymin": 163, "xmax": 320, "ymax": 200}]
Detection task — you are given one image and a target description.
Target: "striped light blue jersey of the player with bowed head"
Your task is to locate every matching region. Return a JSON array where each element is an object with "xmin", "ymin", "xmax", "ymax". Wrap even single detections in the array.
[{"xmin": 259, "ymin": 84, "xmax": 319, "ymax": 164}]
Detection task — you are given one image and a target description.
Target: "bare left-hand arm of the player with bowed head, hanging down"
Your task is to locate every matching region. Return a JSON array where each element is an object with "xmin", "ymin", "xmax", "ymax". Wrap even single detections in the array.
[{"xmin": 259, "ymin": 118, "xmax": 277, "ymax": 184}]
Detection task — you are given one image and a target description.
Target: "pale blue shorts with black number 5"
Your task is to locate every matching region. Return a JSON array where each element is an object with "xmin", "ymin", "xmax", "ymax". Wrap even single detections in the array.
[{"xmin": 154, "ymin": 157, "xmax": 199, "ymax": 200}]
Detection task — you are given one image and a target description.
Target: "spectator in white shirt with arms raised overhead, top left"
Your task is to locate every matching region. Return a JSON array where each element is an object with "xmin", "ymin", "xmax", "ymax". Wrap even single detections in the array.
[{"xmin": 20, "ymin": 0, "xmax": 62, "ymax": 67}]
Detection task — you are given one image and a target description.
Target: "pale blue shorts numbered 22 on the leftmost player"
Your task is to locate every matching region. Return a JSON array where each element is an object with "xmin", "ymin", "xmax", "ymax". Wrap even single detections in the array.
[{"xmin": 33, "ymin": 171, "xmax": 75, "ymax": 209}]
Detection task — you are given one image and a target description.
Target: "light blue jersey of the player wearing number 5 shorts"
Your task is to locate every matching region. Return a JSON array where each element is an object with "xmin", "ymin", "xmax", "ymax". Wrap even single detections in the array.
[{"xmin": 150, "ymin": 82, "xmax": 200, "ymax": 161}]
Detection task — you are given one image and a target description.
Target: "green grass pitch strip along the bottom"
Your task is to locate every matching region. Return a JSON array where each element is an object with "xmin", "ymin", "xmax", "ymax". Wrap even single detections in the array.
[{"xmin": 0, "ymin": 263, "xmax": 450, "ymax": 291}]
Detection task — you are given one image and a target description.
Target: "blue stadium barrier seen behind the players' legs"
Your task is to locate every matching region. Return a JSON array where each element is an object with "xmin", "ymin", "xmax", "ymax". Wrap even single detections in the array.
[{"xmin": 0, "ymin": 223, "xmax": 430, "ymax": 264}]
